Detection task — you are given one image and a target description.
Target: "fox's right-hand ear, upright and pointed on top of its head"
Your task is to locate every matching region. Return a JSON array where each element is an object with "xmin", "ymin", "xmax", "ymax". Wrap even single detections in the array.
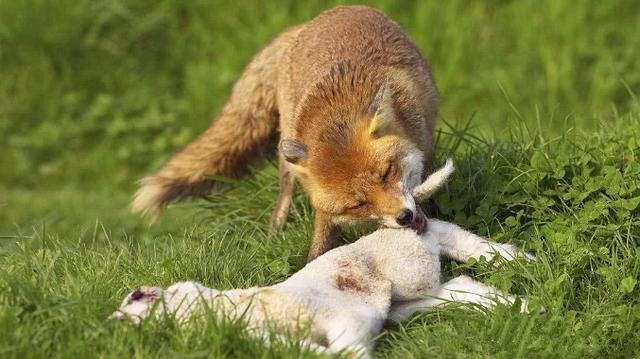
[{"xmin": 366, "ymin": 82, "xmax": 399, "ymax": 137}]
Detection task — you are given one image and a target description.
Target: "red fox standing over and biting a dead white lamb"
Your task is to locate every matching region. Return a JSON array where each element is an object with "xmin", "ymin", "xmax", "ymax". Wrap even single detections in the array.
[{"xmin": 132, "ymin": 6, "xmax": 439, "ymax": 261}]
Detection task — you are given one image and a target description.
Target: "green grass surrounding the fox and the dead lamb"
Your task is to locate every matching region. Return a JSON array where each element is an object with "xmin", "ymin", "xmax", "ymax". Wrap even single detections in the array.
[{"xmin": 0, "ymin": 0, "xmax": 640, "ymax": 358}]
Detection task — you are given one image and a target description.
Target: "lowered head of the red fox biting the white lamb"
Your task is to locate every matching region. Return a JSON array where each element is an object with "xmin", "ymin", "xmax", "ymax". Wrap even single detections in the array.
[{"xmin": 279, "ymin": 80, "xmax": 423, "ymax": 228}]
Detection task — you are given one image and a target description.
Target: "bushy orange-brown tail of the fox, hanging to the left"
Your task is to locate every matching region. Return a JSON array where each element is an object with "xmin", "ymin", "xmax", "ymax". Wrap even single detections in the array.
[{"xmin": 132, "ymin": 27, "xmax": 298, "ymax": 219}]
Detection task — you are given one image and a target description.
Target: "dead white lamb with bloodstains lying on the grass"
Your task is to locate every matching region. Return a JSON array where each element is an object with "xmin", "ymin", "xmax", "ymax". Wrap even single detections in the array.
[{"xmin": 112, "ymin": 160, "xmax": 534, "ymax": 356}]
